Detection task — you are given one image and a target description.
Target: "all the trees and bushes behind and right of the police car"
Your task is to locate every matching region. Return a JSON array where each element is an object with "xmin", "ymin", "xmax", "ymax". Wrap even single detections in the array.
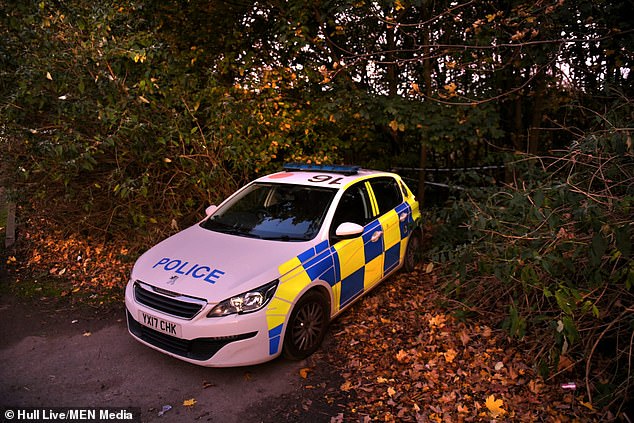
[{"xmin": 0, "ymin": 0, "xmax": 634, "ymax": 418}]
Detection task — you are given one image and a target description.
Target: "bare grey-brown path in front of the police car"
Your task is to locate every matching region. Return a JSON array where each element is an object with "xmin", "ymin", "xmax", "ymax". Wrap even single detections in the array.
[{"xmin": 0, "ymin": 295, "xmax": 344, "ymax": 423}]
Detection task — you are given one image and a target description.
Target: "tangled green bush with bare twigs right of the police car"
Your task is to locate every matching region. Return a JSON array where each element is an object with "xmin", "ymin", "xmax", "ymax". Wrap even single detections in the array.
[{"xmin": 431, "ymin": 123, "xmax": 634, "ymax": 408}]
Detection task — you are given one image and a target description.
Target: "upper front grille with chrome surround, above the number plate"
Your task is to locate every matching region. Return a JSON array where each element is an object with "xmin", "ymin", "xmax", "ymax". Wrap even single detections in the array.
[{"xmin": 134, "ymin": 282, "xmax": 207, "ymax": 319}]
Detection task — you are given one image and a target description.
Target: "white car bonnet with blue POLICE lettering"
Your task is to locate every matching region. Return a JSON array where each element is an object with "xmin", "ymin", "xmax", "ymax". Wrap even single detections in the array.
[{"xmin": 131, "ymin": 225, "xmax": 315, "ymax": 303}]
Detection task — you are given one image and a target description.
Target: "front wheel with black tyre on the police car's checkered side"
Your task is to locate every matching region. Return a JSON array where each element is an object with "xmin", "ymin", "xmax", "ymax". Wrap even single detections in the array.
[{"xmin": 283, "ymin": 291, "xmax": 330, "ymax": 360}]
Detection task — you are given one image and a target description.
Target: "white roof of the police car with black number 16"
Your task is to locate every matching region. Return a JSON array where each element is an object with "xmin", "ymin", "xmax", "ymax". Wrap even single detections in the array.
[{"xmin": 254, "ymin": 167, "xmax": 396, "ymax": 189}]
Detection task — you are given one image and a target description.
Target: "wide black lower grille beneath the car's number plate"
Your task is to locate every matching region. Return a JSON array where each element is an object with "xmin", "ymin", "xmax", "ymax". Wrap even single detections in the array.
[{"xmin": 127, "ymin": 312, "xmax": 257, "ymax": 361}]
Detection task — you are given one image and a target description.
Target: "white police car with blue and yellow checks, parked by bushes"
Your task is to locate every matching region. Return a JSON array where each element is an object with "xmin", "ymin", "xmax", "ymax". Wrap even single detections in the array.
[{"xmin": 125, "ymin": 164, "xmax": 421, "ymax": 367}]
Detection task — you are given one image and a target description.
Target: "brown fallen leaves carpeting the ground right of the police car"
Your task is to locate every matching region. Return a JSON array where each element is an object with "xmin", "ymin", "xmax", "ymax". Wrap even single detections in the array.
[{"xmin": 329, "ymin": 269, "xmax": 592, "ymax": 422}]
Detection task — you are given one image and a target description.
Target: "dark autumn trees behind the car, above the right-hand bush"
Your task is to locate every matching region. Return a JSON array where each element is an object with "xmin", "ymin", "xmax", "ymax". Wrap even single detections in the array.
[{"xmin": 0, "ymin": 0, "xmax": 634, "ymax": 231}]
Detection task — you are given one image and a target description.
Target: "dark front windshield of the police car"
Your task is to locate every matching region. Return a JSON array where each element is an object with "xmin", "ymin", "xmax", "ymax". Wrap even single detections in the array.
[{"xmin": 201, "ymin": 183, "xmax": 337, "ymax": 241}]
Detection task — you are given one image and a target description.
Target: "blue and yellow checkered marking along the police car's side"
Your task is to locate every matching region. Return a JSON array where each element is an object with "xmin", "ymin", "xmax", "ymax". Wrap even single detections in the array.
[{"xmin": 266, "ymin": 202, "xmax": 418, "ymax": 355}]
